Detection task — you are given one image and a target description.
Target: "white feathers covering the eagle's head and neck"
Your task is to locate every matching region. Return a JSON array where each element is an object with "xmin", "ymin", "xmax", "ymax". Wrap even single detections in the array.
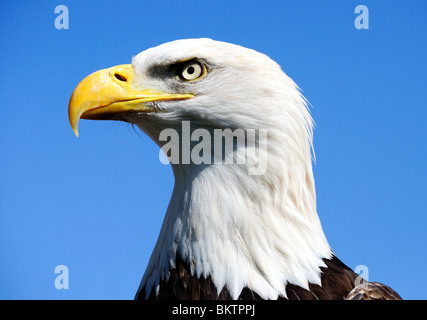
[{"xmin": 127, "ymin": 39, "xmax": 331, "ymax": 299}]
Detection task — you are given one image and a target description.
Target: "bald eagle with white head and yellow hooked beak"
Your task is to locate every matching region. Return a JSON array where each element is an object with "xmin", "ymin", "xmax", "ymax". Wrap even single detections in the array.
[{"xmin": 68, "ymin": 39, "xmax": 400, "ymax": 300}]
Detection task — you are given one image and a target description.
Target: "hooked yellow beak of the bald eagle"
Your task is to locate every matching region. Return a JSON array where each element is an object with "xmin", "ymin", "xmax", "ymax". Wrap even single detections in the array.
[{"xmin": 68, "ymin": 64, "xmax": 194, "ymax": 137}]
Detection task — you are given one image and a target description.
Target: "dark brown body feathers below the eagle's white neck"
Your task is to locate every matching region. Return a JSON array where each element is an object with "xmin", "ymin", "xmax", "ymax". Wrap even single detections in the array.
[{"xmin": 135, "ymin": 256, "xmax": 401, "ymax": 300}]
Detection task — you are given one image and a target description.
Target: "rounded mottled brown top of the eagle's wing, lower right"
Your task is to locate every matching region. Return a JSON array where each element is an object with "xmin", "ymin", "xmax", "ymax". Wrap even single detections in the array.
[{"xmin": 345, "ymin": 282, "xmax": 402, "ymax": 300}]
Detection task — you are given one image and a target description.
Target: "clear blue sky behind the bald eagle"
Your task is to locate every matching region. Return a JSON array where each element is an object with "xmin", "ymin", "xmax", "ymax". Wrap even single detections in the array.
[{"xmin": 0, "ymin": 0, "xmax": 427, "ymax": 299}]
